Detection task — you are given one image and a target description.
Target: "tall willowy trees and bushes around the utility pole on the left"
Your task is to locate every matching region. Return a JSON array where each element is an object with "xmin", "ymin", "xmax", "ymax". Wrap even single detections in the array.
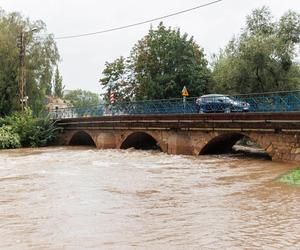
[{"xmin": 0, "ymin": 9, "xmax": 63, "ymax": 149}]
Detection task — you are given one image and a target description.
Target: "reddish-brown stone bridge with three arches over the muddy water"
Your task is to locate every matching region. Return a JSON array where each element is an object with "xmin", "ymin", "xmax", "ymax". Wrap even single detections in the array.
[{"xmin": 57, "ymin": 112, "xmax": 300, "ymax": 161}]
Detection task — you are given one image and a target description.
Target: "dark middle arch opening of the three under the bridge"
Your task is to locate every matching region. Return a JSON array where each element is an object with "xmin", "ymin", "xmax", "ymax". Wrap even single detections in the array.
[{"xmin": 120, "ymin": 132, "xmax": 161, "ymax": 151}]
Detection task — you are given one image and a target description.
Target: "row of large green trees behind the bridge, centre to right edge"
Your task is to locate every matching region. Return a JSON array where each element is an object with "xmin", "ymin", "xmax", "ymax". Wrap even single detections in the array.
[{"xmin": 100, "ymin": 7, "xmax": 300, "ymax": 101}]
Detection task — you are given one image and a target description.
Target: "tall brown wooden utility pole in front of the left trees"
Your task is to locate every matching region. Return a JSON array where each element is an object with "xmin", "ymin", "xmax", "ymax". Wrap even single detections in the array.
[{"xmin": 19, "ymin": 30, "xmax": 27, "ymax": 111}]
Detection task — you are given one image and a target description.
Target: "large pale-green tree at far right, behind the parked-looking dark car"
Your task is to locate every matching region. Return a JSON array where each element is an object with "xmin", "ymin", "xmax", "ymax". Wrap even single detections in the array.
[{"xmin": 213, "ymin": 7, "xmax": 300, "ymax": 94}]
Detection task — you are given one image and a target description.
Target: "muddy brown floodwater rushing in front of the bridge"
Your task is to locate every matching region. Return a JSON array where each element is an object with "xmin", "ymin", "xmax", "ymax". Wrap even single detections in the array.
[{"xmin": 0, "ymin": 147, "xmax": 300, "ymax": 249}]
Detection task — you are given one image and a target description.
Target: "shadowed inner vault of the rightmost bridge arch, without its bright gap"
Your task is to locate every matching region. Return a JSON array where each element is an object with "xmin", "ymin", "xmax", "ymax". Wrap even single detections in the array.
[{"xmin": 199, "ymin": 132, "xmax": 272, "ymax": 159}]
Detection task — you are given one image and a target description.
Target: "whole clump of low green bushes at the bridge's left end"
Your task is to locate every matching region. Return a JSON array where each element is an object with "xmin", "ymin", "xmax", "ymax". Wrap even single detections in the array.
[{"xmin": 0, "ymin": 109, "xmax": 57, "ymax": 149}]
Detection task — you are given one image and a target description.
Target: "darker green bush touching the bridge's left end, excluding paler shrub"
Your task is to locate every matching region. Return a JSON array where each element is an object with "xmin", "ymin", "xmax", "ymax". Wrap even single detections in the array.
[{"xmin": 0, "ymin": 109, "xmax": 57, "ymax": 147}]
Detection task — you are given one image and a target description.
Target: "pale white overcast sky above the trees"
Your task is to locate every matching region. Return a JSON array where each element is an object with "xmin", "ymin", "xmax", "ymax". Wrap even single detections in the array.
[{"xmin": 0, "ymin": 0, "xmax": 300, "ymax": 93}]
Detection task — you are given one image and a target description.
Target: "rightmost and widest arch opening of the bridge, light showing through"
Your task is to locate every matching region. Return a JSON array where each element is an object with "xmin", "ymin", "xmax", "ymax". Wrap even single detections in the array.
[{"xmin": 200, "ymin": 133, "xmax": 272, "ymax": 160}]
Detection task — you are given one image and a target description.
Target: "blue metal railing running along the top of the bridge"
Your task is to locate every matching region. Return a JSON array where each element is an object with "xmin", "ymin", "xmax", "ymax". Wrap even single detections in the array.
[{"xmin": 50, "ymin": 90, "xmax": 300, "ymax": 119}]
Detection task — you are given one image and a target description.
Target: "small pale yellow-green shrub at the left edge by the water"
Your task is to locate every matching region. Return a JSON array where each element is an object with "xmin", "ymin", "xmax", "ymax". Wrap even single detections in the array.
[{"xmin": 0, "ymin": 126, "xmax": 21, "ymax": 149}]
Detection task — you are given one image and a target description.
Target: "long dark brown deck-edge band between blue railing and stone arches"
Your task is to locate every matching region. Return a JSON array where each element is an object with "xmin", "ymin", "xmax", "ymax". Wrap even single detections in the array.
[{"xmin": 57, "ymin": 112, "xmax": 300, "ymax": 133}]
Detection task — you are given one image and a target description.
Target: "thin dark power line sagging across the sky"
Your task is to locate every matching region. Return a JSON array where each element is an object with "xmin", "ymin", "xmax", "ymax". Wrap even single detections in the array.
[{"xmin": 54, "ymin": 0, "xmax": 223, "ymax": 40}]
